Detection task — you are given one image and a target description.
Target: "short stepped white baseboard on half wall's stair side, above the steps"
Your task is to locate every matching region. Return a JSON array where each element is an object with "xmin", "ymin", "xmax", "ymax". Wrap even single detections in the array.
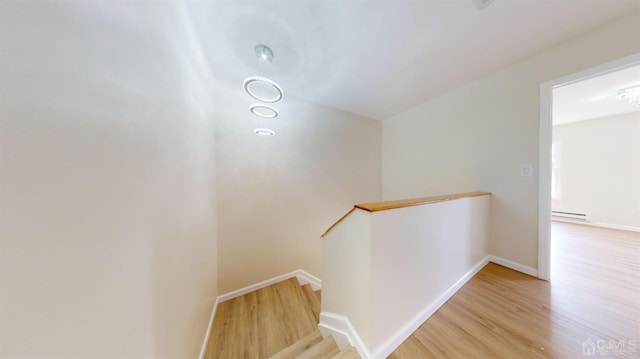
[{"xmin": 318, "ymin": 312, "xmax": 372, "ymax": 359}]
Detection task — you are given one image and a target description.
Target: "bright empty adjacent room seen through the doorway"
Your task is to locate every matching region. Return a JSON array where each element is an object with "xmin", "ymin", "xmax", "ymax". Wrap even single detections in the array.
[{"xmin": 551, "ymin": 66, "xmax": 640, "ymax": 359}]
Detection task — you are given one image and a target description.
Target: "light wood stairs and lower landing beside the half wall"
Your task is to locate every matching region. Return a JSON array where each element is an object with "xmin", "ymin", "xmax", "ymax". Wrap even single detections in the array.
[{"xmin": 205, "ymin": 278, "xmax": 360, "ymax": 359}]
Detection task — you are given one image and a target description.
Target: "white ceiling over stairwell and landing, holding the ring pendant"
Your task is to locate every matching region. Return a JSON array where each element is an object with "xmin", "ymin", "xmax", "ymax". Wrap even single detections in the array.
[{"xmin": 188, "ymin": 0, "xmax": 640, "ymax": 120}]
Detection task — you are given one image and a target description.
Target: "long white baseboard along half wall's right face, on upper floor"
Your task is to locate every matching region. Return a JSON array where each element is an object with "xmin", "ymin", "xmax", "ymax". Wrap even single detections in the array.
[{"xmin": 370, "ymin": 256, "xmax": 491, "ymax": 359}]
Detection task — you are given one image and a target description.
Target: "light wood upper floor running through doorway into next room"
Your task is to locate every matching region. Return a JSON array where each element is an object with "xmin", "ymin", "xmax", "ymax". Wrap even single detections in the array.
[{"xmin": 389, "ymin": 222, "xmax": 640, "ymax": 359}]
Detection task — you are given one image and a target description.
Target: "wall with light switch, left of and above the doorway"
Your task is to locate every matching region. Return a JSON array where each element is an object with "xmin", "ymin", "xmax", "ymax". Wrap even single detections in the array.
[{"xmin": 382, "ymin": 14, "xmax": 640, "ymax": 268}]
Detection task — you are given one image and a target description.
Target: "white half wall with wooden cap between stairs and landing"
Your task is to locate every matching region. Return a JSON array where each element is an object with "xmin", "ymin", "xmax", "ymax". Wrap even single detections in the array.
[{"xmin": 319, "ymin": 192, "xmax": 491, "ymax": 359}]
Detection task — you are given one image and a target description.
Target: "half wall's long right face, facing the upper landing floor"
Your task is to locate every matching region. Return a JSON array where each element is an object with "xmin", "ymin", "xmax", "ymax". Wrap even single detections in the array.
[{"xmin": 371, "ymin": 195, "xmax": 491, "ymax": 358}]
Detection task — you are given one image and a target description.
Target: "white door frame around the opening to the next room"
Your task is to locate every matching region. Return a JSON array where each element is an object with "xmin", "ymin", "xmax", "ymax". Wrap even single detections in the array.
[{"xmin": 538, "ymin": 53, "xmax": 640, "ymax": 280}]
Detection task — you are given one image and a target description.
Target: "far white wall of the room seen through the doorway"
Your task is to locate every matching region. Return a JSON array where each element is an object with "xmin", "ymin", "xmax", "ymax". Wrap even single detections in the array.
[{"xmin": 552, "ymin": 112, "xmax": 640, "ymax": 230}]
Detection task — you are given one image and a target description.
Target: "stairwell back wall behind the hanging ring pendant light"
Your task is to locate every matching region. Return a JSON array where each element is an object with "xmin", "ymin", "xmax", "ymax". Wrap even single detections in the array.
[{"xmin": 216, "ymin": 74, "xmax": 382, "ymax": 293}]
